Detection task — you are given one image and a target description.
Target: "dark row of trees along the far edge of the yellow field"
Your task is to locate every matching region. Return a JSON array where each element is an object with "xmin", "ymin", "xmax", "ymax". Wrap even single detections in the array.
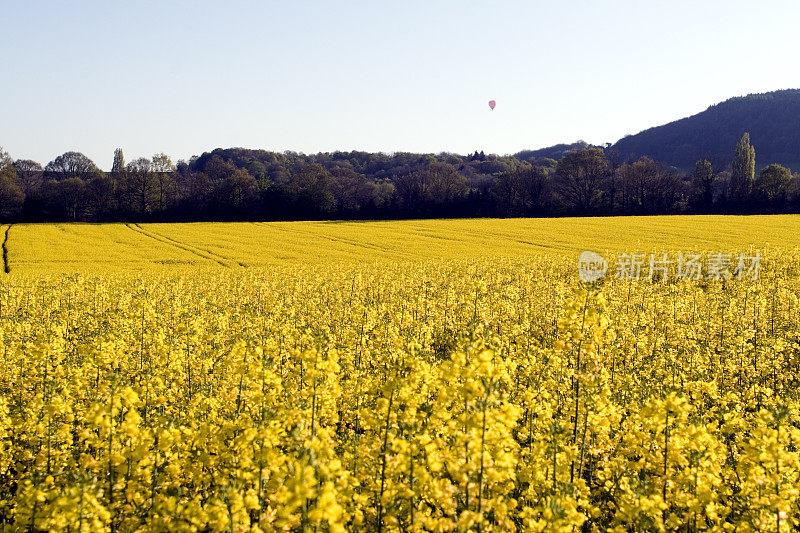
[{"xmin": 0, "ymin": 133, "xmax": 800, "ymax": 222}]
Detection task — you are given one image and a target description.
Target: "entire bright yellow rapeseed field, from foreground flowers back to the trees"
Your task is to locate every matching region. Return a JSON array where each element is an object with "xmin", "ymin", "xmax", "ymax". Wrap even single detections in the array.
[{"xmin": 0, "ymin": 216, "xmax": 800, "ymax": 532}]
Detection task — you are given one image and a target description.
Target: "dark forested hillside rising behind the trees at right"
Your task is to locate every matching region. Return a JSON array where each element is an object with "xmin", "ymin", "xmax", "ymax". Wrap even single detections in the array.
[{"xmin": 613, "ymin": 89, "xmax": 800, "ymax": 170}]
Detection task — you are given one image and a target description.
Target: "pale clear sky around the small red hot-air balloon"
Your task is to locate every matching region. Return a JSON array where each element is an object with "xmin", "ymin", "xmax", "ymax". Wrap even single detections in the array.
[{"xmin": 0, "ymin": 0, "xmax": 800, "ymax": 169}]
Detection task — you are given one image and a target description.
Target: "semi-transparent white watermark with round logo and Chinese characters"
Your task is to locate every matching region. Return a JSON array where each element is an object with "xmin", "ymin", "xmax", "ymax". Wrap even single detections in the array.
[{"xmin": 578, "ymin": 250, "xmax": 761, "ymax": 283}]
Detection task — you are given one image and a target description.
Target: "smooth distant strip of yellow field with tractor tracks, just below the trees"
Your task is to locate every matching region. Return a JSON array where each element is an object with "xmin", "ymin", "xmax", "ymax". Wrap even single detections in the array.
[{"xmin": 9, "ymin": 215, "xmax": 800, "ymax": 274}]
